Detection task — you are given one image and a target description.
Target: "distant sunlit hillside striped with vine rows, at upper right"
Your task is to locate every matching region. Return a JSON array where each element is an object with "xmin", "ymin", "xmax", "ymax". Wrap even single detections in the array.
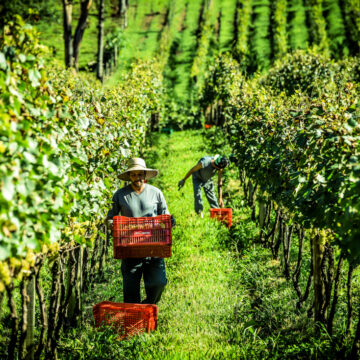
[{"xmin": 151, "ymin": 0, "xmax": 360, "ymax": 129}]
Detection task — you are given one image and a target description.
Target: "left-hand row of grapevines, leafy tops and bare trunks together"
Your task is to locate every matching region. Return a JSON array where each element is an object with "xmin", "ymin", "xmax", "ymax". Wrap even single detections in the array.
[{"xmin": 0, "ymin": 17, "xmax": 162, "ymax": 359}]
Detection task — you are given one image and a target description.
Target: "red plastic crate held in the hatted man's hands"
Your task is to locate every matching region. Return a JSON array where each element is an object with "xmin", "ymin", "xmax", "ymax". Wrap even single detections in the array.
[{"xmin": 113, "ymin": 215, "xmax": 172, "ymax": 259}]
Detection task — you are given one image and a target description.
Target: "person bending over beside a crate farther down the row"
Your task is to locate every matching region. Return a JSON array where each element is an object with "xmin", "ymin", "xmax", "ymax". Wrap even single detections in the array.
[{"xmin": 178, "ymin": 154, "xmax": 229, "ymax": 217}]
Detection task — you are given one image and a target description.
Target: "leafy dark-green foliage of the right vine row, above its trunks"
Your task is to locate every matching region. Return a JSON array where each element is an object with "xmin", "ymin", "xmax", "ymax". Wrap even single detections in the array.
[{"xmin": 204, "ymin": 52, "xmax": 360, "ymax": 257}]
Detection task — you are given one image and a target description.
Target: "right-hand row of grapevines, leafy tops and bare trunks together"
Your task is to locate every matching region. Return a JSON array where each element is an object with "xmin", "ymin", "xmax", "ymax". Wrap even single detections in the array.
[{"xmin": 201, "ymin": 51, "xmax": 360, "ymax": 358}]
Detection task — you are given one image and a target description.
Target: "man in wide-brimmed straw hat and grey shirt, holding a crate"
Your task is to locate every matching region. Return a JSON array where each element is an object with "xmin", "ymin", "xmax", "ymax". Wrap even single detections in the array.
[{"xmin": 107, "ymin": 158, "xmax": 175, "ymax": 304}]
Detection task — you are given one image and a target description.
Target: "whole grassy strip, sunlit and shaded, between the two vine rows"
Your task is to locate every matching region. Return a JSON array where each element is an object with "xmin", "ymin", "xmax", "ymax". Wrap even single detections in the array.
[{"xmin": 54, "ymin": 131, "xmax": 350, "ymax": 360}]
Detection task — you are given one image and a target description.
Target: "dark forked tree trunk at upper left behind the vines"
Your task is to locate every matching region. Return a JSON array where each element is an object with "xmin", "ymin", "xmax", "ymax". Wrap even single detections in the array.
[{"xmin": 62, "ymin": 0, "xmax": 92, "ymax": 70}]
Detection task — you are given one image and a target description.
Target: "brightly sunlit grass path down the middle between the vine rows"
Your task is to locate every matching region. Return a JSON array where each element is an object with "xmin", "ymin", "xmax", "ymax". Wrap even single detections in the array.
[{"xmin": 138, "ymin": 131, "xmax": 243, "ymax": 358}]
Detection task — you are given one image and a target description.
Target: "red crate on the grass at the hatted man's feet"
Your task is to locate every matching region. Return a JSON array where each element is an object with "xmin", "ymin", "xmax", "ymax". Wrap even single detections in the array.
[{"xmin": 93, "ymin": 301, "xmax": 159, "ymax": 339}]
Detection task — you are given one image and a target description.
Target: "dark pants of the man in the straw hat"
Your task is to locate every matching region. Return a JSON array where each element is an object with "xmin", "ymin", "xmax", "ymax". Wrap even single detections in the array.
[{"xmin": 121, "ymin": 257, "xmax": 167, "ymax": 304}]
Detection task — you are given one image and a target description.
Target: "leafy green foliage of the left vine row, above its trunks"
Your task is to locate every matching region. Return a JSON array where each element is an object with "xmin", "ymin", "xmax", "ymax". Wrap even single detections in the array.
[{"xmin": 0, "ymin": 18, "xmax": 161, "ymax": 272}]
